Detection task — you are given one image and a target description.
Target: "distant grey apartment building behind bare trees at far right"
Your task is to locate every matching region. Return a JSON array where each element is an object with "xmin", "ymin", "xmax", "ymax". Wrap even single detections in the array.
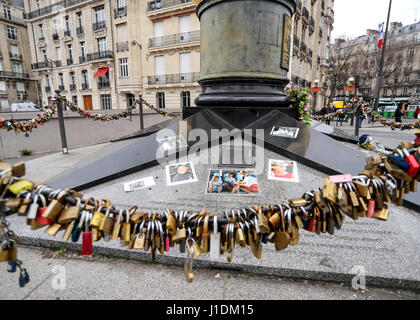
[{"xmin": 334, "ymin": 22, "xmax": 420, "ymax": 104}]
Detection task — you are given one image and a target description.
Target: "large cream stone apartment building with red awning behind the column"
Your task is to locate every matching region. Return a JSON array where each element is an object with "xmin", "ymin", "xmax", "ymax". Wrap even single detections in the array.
[{"xmin": 24, "ymin": 0, "xmax": 334, "ymax": 111}]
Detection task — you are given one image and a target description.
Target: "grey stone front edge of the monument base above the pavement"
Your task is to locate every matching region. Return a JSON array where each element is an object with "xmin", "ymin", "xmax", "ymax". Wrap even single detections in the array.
[{"xmin": 19, "ymin": 237, "xmax": 420, "ymax": 292}]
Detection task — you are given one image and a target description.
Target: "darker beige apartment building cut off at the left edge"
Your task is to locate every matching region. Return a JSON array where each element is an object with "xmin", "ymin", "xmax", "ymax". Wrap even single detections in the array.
[{"xmin": 0, "ymin": 0, "xmax": 41, "ymax": 112}]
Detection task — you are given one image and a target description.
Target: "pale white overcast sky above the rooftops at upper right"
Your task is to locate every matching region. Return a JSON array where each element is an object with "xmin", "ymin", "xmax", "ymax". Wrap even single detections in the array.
[{"xmin": 332, "ymin": 0, "xmax": 420, "ymax": 39}]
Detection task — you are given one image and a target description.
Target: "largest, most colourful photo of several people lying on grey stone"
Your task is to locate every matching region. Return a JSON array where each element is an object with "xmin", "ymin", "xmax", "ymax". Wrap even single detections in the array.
[{"xmin": 207, "ymin": 169, "xmax": 259, "ymax": 195}]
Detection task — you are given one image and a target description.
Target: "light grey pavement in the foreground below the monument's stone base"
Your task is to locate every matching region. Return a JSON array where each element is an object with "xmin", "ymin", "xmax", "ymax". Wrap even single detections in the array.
[{"xmin": 0, "ymin": 247, "xmax": 420, "ymax": 300}]
